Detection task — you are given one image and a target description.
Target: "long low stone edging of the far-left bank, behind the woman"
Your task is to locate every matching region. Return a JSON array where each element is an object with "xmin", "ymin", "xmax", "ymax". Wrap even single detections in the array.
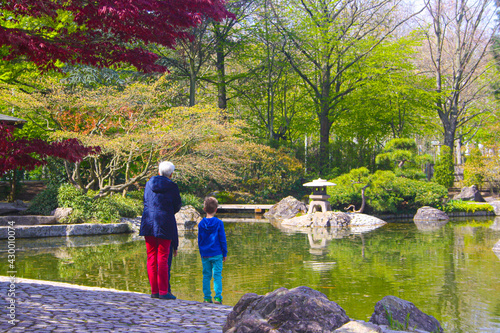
[{"xmin": 0, "ymin": 222, "xmax": 134, "ymax": 239}]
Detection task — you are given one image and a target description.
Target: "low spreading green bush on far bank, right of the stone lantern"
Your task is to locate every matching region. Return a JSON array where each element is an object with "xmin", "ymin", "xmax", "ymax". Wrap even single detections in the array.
[{"xmin": 328, "ymin": 168, "xmax": 448, "ymax": 213}]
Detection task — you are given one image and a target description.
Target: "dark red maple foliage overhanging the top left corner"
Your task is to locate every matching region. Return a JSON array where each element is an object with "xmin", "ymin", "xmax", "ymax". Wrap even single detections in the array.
[{"xmin": 0, "ymin": 0, "xmax": 232, "ymax": 72}]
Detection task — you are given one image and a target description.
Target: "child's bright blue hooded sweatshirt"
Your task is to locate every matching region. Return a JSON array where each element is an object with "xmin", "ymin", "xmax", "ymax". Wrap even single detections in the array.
[{"xmin": 198, "ymin": 216, "xmax": 227, "ymax": 258}]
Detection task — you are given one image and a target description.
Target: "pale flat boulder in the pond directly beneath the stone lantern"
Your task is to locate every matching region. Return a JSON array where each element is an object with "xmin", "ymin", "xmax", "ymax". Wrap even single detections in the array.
[{"xmin": 281, "ymin": 211, "xmax": 351, "ymax": 228}]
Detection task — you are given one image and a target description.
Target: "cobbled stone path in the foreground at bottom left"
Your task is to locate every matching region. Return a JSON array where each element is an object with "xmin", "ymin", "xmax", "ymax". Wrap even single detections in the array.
[{"xmin": 0, "ymin": 276, "xmax": 232, "ymax": 333}]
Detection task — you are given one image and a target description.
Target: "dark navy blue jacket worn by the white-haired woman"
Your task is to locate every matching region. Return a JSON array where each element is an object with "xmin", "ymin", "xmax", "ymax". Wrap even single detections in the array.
[{"xmin": 139, "ymin": 176, "xmax": 182, "ymax": 250}]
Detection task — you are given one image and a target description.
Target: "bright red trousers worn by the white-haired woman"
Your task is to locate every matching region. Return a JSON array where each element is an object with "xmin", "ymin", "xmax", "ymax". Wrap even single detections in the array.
[{"xmin": 144, "ymin": 236, "xmax": 171, "ymax": 295}]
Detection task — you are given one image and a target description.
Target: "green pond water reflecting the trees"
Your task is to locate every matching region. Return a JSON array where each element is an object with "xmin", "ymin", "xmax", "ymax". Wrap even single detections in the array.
[{"xmin": 0, "ymin": 216, "xmax": 500, "ymax": 333}]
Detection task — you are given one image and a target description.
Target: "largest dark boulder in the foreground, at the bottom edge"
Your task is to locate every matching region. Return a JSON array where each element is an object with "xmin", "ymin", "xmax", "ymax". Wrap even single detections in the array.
[{"xmin": 222, "ymin": 286, "xmax": 350, "ymax": 333}]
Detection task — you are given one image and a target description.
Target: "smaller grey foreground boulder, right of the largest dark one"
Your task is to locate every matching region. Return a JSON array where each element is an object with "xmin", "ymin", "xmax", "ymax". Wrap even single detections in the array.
[{"xmin": 370, "ymin": 296, "xmax": 443, "ymax": 332}]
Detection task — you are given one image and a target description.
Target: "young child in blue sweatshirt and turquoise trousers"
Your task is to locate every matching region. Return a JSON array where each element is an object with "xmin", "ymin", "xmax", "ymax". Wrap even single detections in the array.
[{"xmin": 198, "ymin": 197, "xmax": 227, "ymax": 304}]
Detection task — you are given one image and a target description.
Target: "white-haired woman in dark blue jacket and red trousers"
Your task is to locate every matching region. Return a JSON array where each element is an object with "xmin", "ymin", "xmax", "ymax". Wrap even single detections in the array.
[{"xmin": 139, "ymin": 162, "xmax": 181, "ymax": 299}]
